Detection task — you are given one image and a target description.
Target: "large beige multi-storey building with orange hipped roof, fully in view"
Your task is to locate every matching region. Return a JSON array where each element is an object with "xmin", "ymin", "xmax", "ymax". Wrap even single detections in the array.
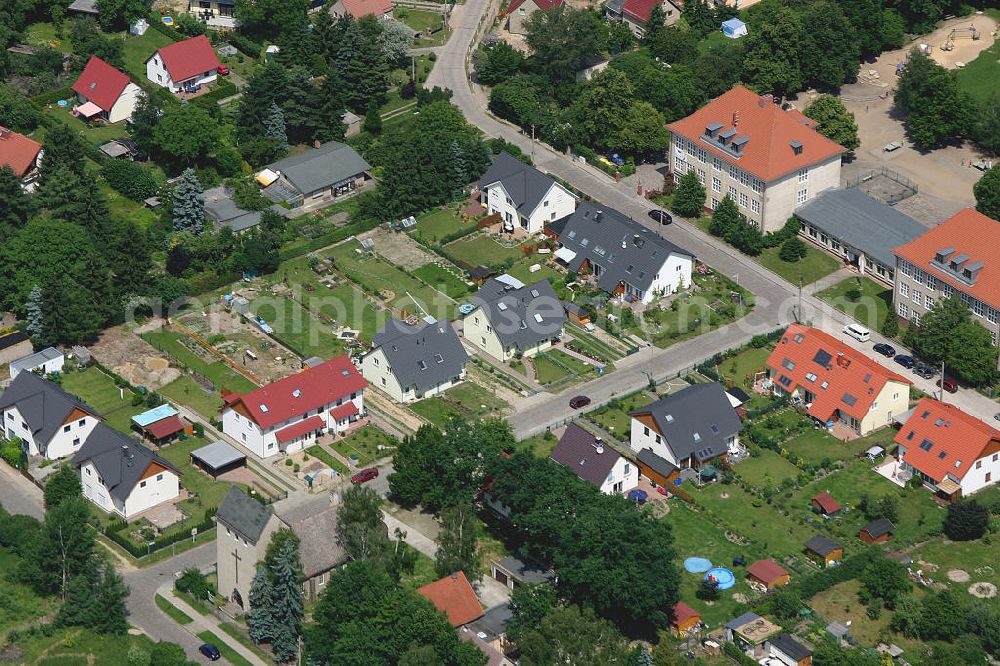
[{"xmin": 667, "ymin": 86, "xmax": 844, "ymax": 233}]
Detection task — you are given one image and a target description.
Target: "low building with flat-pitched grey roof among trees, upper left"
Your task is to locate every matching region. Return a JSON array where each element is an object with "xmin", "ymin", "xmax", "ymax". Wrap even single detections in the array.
[{"xmin": 257, "ymin": 141, "xmax": 374, "ymax": 207}]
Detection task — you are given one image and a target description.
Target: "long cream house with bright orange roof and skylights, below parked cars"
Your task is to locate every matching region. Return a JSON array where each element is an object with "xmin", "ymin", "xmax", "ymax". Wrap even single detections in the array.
[{"xmin": 767, "ymin": 324, "xmax": 912, "ymax": 439}]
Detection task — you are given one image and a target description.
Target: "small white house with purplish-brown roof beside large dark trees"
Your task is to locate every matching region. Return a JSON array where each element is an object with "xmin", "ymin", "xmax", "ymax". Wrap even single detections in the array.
[{"xmin": 549, "ymin": 423, "xmax": 639, "ymax": 495}]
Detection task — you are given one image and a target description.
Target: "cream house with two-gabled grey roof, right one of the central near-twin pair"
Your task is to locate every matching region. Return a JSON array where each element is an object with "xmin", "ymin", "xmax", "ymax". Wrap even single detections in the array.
[{"xmin": 462, "ymin": 276, "xmax": 566, "ymax": 362}]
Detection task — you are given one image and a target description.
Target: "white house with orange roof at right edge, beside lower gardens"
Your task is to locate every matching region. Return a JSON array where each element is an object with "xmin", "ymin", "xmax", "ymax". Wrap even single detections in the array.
[{"xmin": 896, "ymin": 398, "xmax": 1000, "ymax": 501}]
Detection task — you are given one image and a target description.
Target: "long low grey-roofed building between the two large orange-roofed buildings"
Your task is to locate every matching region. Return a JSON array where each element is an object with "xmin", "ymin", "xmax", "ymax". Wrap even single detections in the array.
[{"xmin": 795, "ymin": 188, "xmax": 927, "ymax": 287}]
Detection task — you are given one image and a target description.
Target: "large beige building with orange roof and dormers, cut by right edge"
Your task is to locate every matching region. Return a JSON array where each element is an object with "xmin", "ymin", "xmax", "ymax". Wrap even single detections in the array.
[{"xmin": 893, "ymin": 208, "xmax": 1000, "ymax": 366}]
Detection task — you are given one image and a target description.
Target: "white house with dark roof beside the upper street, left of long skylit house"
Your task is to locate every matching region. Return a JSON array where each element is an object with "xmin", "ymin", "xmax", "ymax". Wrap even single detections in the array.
[{"xmin": 479, "ymin": 153, "xmax": 576, "ymax": 234}]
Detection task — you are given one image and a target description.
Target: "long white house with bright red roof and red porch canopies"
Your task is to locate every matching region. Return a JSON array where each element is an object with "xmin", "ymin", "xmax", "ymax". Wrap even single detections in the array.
[{"xmin": 222, "ymin": 355, "xmax": 368, "ymax": 458}]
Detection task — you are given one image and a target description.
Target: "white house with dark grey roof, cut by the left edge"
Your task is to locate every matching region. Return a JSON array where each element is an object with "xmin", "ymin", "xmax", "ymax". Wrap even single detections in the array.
[{"xmin": 0, "ymin": 372, "xmax": 101, "ymax": 460}]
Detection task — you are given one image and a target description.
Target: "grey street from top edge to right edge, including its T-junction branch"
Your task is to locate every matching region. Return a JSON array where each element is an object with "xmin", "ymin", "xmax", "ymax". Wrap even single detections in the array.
[{"xmin": 426, "ymin": 5, "xmax": 997, "ymax": 438}]
